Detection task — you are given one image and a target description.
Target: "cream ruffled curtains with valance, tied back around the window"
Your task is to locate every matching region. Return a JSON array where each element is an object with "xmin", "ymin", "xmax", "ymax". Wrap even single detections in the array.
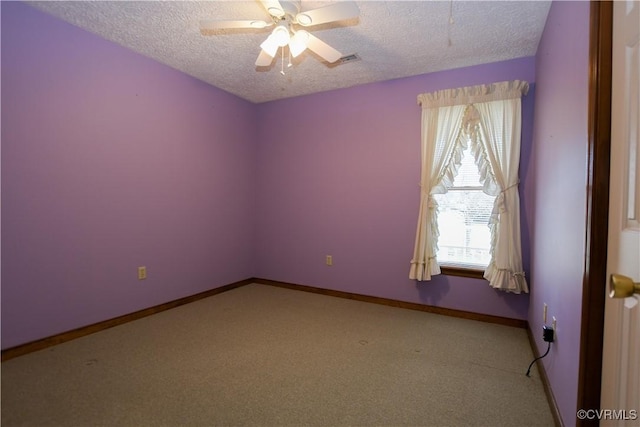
[{"xmin": 409, "ymin": 80, "xmax": 529, "ymax": 293}]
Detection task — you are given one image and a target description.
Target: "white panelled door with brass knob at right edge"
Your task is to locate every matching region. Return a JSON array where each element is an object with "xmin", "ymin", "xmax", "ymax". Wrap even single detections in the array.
[{"xmin": 604, "ymin": 0, "xmax": 640, "ymax": 426}]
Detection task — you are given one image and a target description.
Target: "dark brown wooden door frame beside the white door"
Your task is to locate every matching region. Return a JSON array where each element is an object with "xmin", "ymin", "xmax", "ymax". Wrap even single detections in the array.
[{"xmin": 576, "ymin": 1, "xmax": 613, "ymax": 426}]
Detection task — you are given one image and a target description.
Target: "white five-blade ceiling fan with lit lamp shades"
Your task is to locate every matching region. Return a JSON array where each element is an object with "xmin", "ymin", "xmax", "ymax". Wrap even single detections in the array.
[{"xmin": 200, "ymin": 0, "xmax": 360, "ymax": 67}]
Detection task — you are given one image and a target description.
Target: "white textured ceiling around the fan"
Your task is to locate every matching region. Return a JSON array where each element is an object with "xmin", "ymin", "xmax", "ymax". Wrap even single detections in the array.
[{"xmin": 29, "ymin": 0, "xmax": 551, "ymax": 103}]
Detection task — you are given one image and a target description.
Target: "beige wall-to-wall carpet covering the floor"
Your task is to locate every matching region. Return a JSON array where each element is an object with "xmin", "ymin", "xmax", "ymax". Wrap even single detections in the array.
[{"xmin": 1, "ymin": 284, "xmax": 553, "ymax": 427}]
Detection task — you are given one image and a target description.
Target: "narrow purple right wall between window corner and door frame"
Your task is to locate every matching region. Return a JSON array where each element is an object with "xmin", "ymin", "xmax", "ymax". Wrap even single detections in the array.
[{"xmin": 529, "ymin": 2, "xmax": 590, "ymax": 426}]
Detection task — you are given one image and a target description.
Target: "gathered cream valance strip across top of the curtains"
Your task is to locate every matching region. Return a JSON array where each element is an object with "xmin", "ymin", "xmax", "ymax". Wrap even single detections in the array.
[{"xmin": 418, "ymin": 80, "xmax": 529, "ymax": 108}]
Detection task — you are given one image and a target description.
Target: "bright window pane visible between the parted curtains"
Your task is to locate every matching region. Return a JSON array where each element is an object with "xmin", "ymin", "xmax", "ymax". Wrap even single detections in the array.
[{"xmin": 434, "ymin": 148, "xmax": 495, "ymax": 270}]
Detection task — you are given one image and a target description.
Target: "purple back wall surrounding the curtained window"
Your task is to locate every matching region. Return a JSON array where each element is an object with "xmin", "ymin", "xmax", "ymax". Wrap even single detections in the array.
[{"xmin": 256, "ymin": 58, "xmax": 535, "ymax": 319}]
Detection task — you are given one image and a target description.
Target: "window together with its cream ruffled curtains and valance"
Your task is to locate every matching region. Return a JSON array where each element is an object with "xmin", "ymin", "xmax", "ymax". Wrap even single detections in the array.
[{"xmin": 409, "ymin": 80, "xmax": 529, "ymax": 294}]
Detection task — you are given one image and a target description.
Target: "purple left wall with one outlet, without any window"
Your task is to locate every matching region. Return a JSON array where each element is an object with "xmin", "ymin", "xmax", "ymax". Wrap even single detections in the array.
[{"xmin": 2, "ymin": 2, "xmax": 256, "ymax": 348}]
